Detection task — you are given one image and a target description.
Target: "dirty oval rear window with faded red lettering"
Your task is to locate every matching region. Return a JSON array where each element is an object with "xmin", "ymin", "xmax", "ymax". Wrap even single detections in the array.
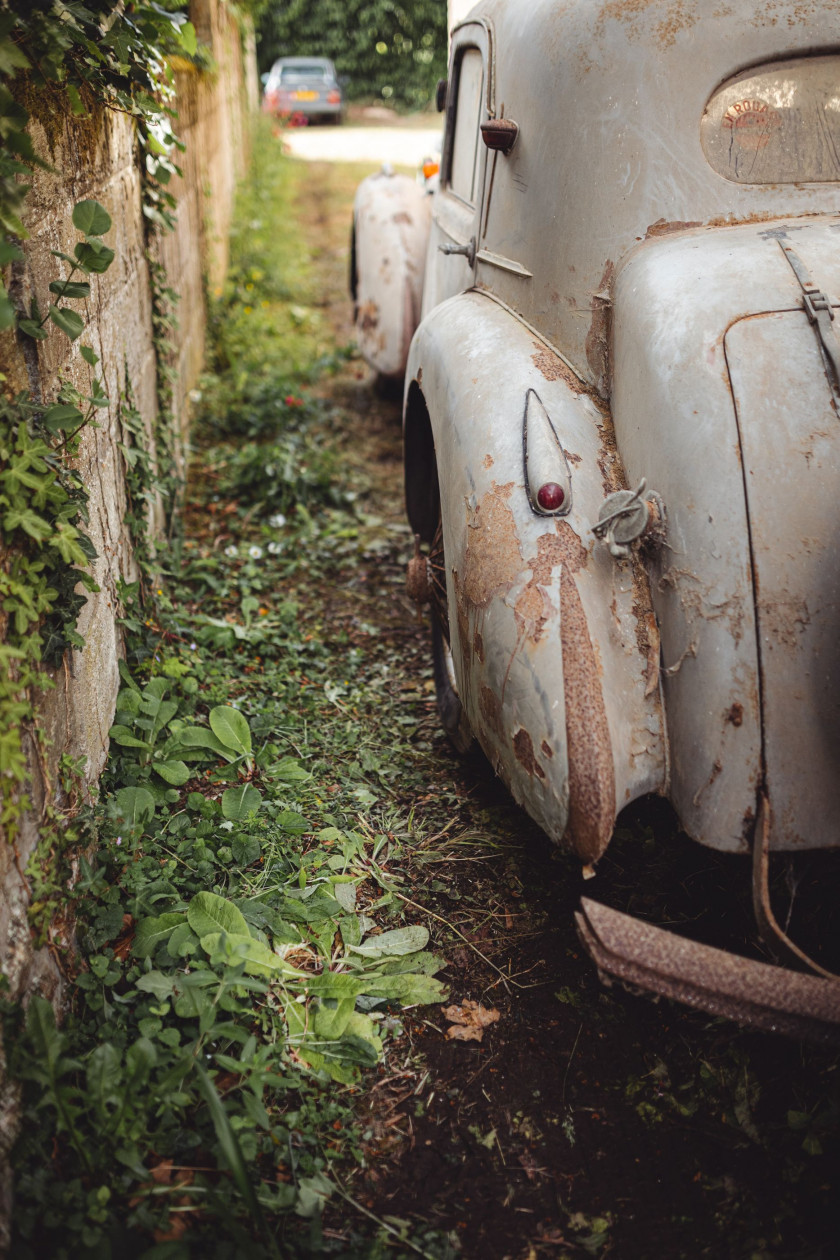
[{"xmin": 700, "ymin": 57, "xmax": 840, "ymax": 184}]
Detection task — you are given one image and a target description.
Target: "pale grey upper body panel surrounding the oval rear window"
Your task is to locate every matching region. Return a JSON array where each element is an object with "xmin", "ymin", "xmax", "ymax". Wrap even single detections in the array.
[{"xmin": 463, "ymin": 0, "xmax": 840, "ymax": 397}]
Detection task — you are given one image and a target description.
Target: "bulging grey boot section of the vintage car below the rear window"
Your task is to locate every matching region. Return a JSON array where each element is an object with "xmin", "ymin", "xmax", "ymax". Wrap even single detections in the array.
[{"xmin": 612, "ymin": 215, "xmax": 840, "ymax": 851}]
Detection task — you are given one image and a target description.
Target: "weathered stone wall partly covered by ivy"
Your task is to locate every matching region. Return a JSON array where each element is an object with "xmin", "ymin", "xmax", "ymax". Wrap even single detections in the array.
[{"xmin": 0, "ymin": 0, "xmax": 257, "ymax": 1255}]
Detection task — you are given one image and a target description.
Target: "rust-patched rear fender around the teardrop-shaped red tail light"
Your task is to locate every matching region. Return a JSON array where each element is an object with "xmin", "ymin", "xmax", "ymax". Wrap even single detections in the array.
[{"xmin": 407, "ymin": 291, "xmax": 666, "ymax": 863}]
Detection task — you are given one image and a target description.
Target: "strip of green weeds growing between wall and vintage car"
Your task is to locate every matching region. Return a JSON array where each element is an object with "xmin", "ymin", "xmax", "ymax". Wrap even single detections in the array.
[{"xmin": 6, "ymin": 125, "xmax": 451, "ymax": 1260}]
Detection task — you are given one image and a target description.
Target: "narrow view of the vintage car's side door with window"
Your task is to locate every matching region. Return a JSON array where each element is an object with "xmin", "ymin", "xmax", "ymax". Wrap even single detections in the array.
[{"xmin": 423, "ymin": 21, "xmax": 495, "ymax": 314}]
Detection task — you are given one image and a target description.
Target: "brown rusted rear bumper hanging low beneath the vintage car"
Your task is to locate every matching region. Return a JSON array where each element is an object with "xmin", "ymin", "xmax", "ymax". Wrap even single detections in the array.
[{"xmin": 574, "ymin": 897, "xmax": 840, "ymax": 1046}]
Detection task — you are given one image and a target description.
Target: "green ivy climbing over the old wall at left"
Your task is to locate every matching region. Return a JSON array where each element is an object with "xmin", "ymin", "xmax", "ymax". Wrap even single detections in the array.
[{"xmin": 0, "ymin": 0, "xmax": 196, "ymax": 839}]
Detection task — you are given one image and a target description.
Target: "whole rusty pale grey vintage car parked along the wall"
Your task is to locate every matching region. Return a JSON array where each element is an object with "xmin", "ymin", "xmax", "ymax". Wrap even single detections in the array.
[{"xmin": 354, "ymin": 0, "xmax": 840, "ymax": 1040}]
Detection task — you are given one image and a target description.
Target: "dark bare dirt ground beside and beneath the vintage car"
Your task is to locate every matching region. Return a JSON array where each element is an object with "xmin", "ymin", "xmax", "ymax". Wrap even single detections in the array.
[{"xmin": 290, "ymin": 163, "xmax": 840, "ymax": 1260}]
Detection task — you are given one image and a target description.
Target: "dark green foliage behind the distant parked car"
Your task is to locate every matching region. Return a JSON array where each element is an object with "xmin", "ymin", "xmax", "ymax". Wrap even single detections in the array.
[{"xmin": 258, "ymin": 0, "xmax": 447, "ymax": 108}]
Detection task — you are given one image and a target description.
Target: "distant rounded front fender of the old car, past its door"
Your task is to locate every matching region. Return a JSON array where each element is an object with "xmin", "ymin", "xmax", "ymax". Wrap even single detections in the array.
[{"xmin": 351, "ymin": 169, "xmax": 429, "ymax": 377}]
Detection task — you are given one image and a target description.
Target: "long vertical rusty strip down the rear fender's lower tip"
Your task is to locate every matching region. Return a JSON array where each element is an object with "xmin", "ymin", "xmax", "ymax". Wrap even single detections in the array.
[{"xmin": 560, "ymin": 567, "xmax": 616, "ymax": 862}]
